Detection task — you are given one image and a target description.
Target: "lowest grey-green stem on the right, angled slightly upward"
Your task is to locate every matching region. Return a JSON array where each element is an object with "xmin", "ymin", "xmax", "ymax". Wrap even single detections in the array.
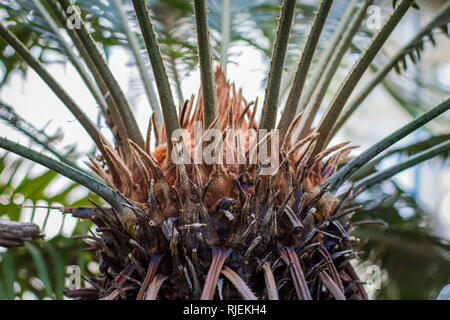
[{"xmin": 355, "ymin": 141, "xmax": 450, "ymax": 190}]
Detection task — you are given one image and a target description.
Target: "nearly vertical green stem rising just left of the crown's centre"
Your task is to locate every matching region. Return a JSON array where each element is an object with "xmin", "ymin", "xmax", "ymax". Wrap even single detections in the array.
[{"xmin": 194, "ymin": 0, "xmax": 218, "ymax": 128}]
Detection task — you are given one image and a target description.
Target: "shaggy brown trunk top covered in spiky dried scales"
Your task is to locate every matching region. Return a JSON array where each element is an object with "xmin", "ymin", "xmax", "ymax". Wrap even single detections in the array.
[{"xmin": 66, "ymin": 68, "xmax": 367, "ymax": 300}]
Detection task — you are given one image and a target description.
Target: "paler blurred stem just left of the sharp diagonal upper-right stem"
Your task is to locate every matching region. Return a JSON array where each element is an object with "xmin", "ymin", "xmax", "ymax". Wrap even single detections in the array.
[{"xmin": 298, "ymin": 0, "xmax": 373, "ymax": 139}]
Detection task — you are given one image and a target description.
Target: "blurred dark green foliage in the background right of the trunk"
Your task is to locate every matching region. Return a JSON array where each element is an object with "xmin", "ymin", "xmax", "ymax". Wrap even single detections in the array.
[{"xmin": 352, "ymin": 182, "xmax": 450, "ymax": 299}]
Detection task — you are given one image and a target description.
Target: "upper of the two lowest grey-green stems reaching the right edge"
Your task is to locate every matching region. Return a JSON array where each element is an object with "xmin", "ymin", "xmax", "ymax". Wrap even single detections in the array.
[{"xmin": 324, "ymin": 99, "xmax": 450, "ymax": 191}]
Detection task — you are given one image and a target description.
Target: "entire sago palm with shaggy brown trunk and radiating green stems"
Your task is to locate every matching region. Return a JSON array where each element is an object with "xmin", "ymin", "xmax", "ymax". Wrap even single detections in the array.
[{"xmin": 0, "ymin": 0, "xmax": 450, "ymax": 300}]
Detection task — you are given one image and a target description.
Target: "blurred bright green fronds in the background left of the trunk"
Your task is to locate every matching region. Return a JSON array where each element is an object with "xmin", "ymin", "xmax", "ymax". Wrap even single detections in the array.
[{"xmin": 0, "ymin": 153, "xmax": 101, "ymax": 299}]
